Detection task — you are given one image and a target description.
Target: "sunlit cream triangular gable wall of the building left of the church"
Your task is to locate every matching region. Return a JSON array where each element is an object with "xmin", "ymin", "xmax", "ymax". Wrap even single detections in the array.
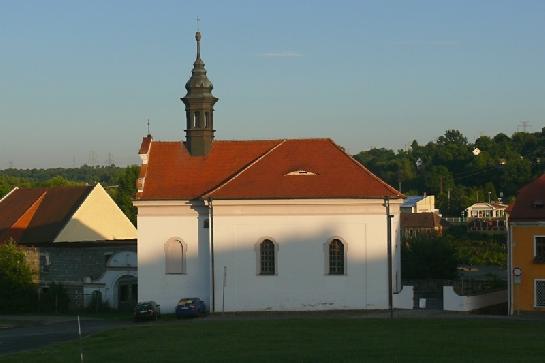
[{"xmin": 54, "ymin": 184, "xmax": 136, "ymax": 242}]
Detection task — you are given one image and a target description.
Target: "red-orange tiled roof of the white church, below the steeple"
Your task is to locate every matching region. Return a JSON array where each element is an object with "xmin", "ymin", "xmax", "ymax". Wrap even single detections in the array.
[{"xmin": 138, "ymin": 139, "xmax": 401, "ymax": 200}]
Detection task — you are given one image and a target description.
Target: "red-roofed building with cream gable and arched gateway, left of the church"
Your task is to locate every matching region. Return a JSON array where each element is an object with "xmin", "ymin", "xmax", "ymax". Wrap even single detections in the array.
[{"xmin": 0, "ymin": 184, "xmax": 137, "ymax": 308}]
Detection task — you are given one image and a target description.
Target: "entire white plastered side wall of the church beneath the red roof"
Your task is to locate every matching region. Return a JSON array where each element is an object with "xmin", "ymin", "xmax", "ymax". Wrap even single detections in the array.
[{"xmin": 137, "ymin": 200, "xmax": 401, "ymax": 312}]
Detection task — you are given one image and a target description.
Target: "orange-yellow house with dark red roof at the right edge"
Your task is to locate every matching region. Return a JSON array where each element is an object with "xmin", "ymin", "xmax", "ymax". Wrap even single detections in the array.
[{"xmin": 508, "ymin": 175, "xmax": 545, "ymax": 314}]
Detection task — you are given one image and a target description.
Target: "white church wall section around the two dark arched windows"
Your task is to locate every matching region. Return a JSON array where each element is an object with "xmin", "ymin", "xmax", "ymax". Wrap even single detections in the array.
[{"xmin": 214, "ymin": 200, "xmax": 401, "ymax": 311}]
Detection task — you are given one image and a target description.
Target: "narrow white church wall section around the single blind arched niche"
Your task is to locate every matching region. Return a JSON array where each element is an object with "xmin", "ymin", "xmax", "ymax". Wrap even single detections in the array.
[{"xmin": 138, "ymin": 206, "xmax": 210, "ymax": 314}]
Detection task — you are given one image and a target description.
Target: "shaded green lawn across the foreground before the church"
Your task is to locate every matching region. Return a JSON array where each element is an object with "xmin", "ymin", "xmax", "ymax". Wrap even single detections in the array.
[{"xmin": 0, "ymin": 318, "xmax": 545, "ymax": 363}]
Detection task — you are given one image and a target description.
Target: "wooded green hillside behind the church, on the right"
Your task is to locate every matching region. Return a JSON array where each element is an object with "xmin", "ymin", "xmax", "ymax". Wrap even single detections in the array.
[{"xmin": 355, "ymin": 130, "xmax": 545, "ymax": 217}]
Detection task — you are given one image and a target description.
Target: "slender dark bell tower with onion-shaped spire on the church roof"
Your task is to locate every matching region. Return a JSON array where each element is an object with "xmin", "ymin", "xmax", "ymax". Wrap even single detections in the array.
[{"xmin": 181, "ymin": 32, "xmax": 218, "ymax": 156}]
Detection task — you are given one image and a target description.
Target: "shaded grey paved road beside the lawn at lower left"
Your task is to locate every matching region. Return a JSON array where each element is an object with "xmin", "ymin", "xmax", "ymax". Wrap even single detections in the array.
[{"xmin": 0, "ymin": 318, "xmax": 127, "ymax": 355}]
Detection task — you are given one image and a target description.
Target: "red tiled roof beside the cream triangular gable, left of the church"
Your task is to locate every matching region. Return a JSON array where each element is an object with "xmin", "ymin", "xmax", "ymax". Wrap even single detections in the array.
[{"xmin": 0, "ymin": 186, "xmax": 93, "ymax": 244}]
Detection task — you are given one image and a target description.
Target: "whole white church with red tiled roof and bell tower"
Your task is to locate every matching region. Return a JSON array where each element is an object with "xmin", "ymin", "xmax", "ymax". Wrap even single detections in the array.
[{"xmin": 134, "ymin": 32, "xmax": 403, "ymax": 311}]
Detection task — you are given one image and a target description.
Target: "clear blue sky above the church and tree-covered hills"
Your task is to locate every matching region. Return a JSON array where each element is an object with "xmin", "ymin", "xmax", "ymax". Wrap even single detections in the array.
[{"xmin": 0, "ymin": 0, "xmax": 545, "ymax": 169}]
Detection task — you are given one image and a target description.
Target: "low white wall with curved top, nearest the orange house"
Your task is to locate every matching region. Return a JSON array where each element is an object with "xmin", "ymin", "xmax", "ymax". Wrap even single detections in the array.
[{"xmin": 443, "ymin": 286, "xmax": 507, "ymax": 311}]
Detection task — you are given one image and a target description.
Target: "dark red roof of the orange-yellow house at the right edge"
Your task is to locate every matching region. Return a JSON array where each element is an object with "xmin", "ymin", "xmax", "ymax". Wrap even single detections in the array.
[{"xmin": 509, "ymin": 174, "xmax": 545, "ymax": 220}]
